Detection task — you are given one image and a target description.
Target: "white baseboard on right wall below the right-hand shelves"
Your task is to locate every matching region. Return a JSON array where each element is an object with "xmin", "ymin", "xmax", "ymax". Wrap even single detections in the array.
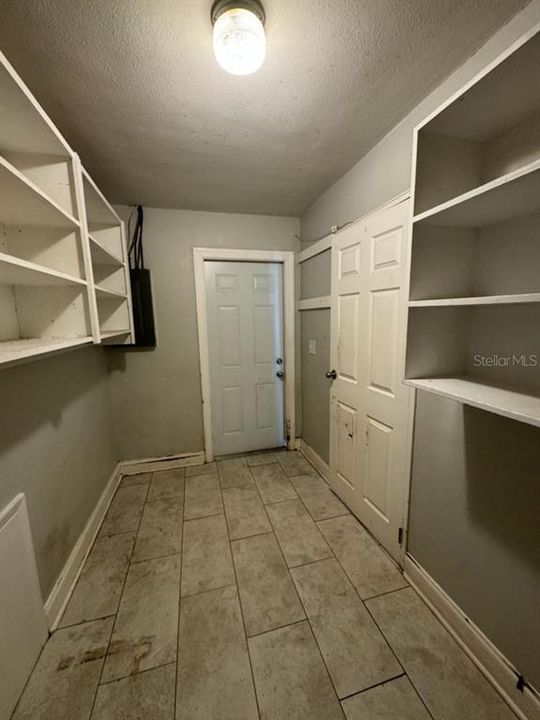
[{"xmin": 404, "ymin": 554, "xmax": 540, "ymax": 720}]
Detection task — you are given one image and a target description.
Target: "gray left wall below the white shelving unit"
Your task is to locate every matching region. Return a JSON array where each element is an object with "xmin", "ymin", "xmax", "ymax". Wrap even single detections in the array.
[{"xmin": 0, "ymin": 348, "xmax": 117, "ymax": 600}]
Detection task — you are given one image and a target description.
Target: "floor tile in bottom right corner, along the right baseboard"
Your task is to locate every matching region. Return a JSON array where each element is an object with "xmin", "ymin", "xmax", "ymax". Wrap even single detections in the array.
[{"xmin": 366, "ymin": 588, "xmax": 515, "ymax": 720}]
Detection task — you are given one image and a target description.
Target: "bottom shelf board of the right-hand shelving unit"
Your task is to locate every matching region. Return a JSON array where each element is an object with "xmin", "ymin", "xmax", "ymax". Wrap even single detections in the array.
[{"xmin": 405, "ymin": 376, "xmax": 540, "ymax": 427}]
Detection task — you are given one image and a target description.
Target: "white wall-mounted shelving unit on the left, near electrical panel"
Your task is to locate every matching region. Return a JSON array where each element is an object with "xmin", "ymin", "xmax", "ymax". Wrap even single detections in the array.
[{"xmin": 0, "ymin": 47, "xmax": 132, "ymax": 365}]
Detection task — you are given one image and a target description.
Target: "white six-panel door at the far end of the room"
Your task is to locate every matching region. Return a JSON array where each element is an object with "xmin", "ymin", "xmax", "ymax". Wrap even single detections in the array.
[{"xmin": 204, "ymin": 261, "xmax": 285, "ymax": 455}]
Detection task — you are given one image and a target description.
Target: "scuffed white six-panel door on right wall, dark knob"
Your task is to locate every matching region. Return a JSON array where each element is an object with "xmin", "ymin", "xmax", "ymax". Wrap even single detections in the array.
[{"xmin": 330, "ymin": 201, "xmax": 413, "ymax": 560}]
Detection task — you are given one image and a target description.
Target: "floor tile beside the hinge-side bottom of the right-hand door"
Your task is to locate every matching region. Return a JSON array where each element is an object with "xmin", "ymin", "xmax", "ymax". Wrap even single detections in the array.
[{"xmin": 317, "ymin": 515, "xmax": 407, "ymax": 598}]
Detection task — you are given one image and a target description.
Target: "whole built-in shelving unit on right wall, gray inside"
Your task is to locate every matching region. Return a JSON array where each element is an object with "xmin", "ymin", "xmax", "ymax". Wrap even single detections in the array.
[{"xmin": 405, "ymin": 26, "xmax": 540, "ymax": 426}]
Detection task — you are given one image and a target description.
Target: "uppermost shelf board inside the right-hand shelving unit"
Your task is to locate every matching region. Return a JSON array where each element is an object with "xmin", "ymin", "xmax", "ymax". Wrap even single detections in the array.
[{"xmin": 413, "ymin": 160, "xmax": 540, "ymax": 228}]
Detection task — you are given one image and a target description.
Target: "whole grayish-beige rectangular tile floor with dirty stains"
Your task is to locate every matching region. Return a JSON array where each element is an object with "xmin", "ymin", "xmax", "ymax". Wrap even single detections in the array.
[{"xmin": 13, "ymin": 451, "xmax": 515, "ymax": 720}]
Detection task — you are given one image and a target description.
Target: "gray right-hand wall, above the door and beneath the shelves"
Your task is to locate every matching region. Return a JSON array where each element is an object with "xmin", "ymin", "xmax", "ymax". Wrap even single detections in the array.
[{"xmin": 301, "ymin": 0, "xmax": 540, "ymax": 687}]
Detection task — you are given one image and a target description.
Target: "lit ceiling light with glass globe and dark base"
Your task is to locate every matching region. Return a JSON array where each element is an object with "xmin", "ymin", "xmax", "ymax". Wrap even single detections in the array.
[{"xmin": 211, "ymin": 0, "xmax": 266, "ymax": 75}]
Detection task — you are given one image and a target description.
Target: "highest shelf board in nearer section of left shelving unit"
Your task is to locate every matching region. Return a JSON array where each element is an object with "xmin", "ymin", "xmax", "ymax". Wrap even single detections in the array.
[{"xmin": 0, "ymin": 156, "xmax": 79, "ymax": 230}]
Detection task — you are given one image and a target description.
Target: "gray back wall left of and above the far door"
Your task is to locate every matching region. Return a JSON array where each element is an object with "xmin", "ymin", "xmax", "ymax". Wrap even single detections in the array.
[{"xmin": 108, "ymin": 208, "xmax": 299, "ymax": 458}]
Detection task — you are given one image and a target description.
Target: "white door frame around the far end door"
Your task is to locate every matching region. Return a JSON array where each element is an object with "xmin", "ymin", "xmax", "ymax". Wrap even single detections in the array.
[{"xmin": 193, "ymin": 247, "xmax": 296, "ymax": 462}]
